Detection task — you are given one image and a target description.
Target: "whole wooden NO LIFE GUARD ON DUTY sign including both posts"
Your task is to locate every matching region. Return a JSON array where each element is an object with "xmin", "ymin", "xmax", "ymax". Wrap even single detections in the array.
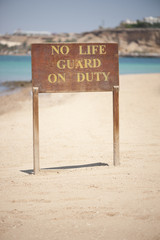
[{"xmin": 32, "ymin": 43, "xmax": 119, "ymax": 174}]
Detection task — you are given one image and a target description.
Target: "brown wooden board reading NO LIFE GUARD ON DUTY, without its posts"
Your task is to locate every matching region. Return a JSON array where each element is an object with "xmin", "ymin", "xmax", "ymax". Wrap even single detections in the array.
[{"xmin": 32, "ymin": 43, "xmax": 119, "ymax": 93}]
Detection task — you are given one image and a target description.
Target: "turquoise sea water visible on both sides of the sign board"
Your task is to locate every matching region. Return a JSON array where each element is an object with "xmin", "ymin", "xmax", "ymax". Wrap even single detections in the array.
[{"xmin": 0, "ymin": 56, "xmax": 160, "ymax": 84}]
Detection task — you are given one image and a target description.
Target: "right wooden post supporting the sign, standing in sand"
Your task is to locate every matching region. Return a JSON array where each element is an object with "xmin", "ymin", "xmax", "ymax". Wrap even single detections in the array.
[{"xmin": 113, "ymin": 86, "xmax": 120, "ymax": 166}]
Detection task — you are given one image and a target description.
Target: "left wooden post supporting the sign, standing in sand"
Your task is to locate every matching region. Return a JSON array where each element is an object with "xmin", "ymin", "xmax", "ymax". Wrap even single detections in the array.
[{"xmin": 33, "ymin": 87, "xmax": 40, "ymax": 174}]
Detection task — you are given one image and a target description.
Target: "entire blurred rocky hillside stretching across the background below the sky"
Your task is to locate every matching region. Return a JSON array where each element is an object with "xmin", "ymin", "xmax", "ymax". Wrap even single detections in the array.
[{"xmin": 0, "ymin": 28, "xmax": 160, "ymax": 57}]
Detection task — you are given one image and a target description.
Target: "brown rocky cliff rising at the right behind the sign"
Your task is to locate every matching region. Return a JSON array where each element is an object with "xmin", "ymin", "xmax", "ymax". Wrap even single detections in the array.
[{"xmin": 78, "ymin": 29, "xmax": 160, "ymax": 56}]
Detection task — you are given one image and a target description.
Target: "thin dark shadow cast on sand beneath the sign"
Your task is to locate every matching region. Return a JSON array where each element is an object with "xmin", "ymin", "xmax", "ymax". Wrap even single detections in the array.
[{"xmin": 20, "ymin": 162, "xmax": 109, "ymax": 174}]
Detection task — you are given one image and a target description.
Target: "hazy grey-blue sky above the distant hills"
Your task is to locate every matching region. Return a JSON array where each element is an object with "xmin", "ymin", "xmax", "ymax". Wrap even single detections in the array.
[{"xmin": 0, "ymin": 0, "xmax": 160, "ymax": 34}]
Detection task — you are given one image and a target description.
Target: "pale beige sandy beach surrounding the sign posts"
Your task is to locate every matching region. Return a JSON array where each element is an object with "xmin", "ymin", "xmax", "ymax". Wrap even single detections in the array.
[{"xmin": 0, "ymin": 74, "xmax": 160, "ymax": 240}]
